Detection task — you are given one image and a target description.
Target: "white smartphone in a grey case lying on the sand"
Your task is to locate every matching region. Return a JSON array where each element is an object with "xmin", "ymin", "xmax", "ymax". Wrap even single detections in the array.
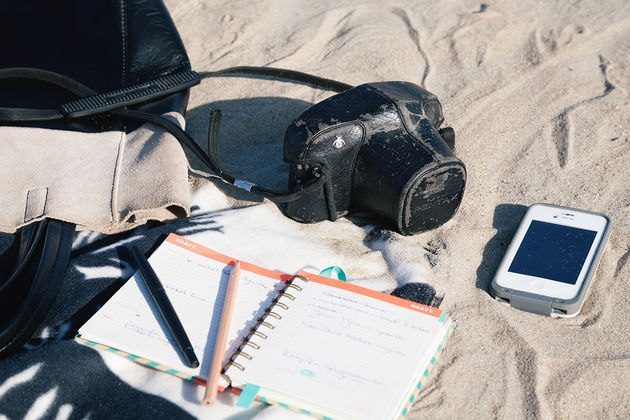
[{"xmin": 490, "ymin": 204, "xmax": 610, "ymax": 317}]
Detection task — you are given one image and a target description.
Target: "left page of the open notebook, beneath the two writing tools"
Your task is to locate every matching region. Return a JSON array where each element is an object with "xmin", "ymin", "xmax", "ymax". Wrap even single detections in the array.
[{"xmin": 79, "ymin": 234, "xmax": 290, "ymax": 386}]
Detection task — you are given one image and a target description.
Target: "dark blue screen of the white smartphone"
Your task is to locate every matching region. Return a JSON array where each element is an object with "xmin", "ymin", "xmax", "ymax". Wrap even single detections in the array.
[{"xmin": 508, "ymin": 220, "xmax": 597, "ymax": 284}]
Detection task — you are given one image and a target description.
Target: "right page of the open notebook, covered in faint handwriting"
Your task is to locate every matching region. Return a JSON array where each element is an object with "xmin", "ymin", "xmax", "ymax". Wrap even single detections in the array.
[{"xmin": 227, "ymin": 275, "xmax": 446, "ymax": 419}]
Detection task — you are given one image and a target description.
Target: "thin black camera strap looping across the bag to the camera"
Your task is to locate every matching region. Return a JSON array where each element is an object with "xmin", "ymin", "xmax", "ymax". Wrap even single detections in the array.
[{"xmin": 0, "ymin": 66, "xmax": 352, "ymax": 202}]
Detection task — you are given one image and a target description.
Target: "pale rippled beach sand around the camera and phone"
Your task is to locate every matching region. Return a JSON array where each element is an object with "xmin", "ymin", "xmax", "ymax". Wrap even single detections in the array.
[{"xmin": 166, "ymin": 0, "xmax": 630, "ymax": 418}]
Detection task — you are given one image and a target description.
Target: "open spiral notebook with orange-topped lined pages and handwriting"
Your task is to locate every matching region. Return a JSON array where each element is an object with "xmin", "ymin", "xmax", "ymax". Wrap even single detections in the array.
[{"xmin": 76, "ymin": 234, "xmax": 454, "ymax": 419}]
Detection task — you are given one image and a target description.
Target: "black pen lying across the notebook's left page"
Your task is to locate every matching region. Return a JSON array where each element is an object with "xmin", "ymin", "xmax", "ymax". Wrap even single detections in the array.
[{"xmin": 130, "ymin": 245, "xmax": 199, "ymax": 368}]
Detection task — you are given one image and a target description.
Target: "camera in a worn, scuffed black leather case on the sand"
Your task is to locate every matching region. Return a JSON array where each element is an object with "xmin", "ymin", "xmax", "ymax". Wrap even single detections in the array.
[{"xmin": 284, "ymin": 82, "xmax": 466, "ymax": 235}]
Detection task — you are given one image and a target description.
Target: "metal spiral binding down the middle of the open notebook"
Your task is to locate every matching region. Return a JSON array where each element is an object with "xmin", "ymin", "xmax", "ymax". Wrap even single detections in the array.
[{"xmin": 223, "ymin": 275, "xmax": 308, "ymax": 372}]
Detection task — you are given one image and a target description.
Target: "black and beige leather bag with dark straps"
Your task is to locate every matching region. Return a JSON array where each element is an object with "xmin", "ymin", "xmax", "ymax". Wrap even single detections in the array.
[{"xmin": 0, "ymin": 0, "xmax": 199, "ymax": 357}]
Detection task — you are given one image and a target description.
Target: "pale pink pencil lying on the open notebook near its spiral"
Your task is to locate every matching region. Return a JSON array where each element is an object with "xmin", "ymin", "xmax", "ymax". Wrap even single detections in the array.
[{"xmin": 203, "ymin": 261, "xmax": 241, "ymax": 406}]
